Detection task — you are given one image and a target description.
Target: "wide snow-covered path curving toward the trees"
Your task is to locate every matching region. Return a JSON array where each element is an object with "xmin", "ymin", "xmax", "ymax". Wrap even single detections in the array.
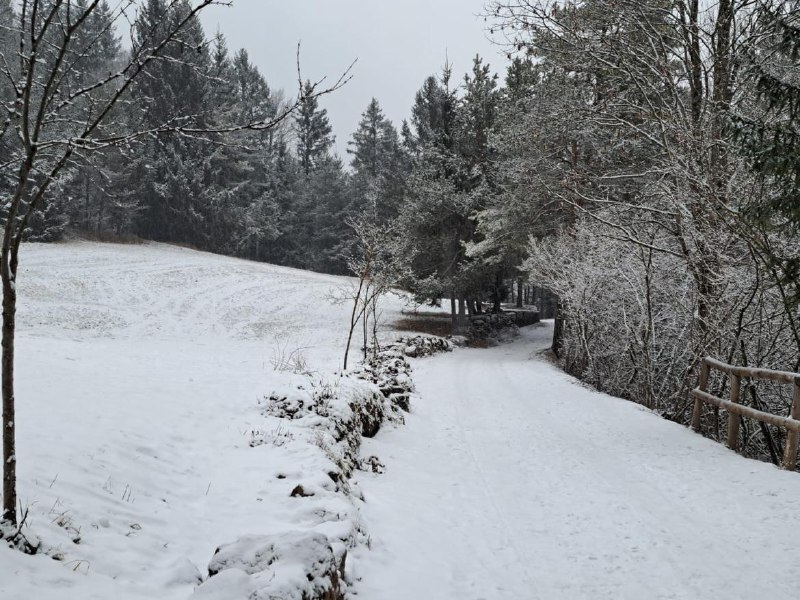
[{"xmin": 357, "ymin": 328, "xmax": 800, "ymax": 600}]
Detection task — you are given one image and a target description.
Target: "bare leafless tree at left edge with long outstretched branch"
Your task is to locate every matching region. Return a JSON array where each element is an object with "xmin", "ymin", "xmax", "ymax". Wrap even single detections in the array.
[{"xmin": 0, "ymin": 0, "xmax": 349, "ymax": 525}]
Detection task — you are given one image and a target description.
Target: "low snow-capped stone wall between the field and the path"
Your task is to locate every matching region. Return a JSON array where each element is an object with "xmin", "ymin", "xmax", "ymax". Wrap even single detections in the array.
[{"xmin": 195, "ymin": 336, "xmax": 450, "ymax": 600}]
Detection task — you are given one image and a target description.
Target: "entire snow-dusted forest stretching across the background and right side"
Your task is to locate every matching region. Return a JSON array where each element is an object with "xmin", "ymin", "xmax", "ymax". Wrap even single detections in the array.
[{"xmin": 0, "ymin": 0, "xmax": 800, "ymax": 502}]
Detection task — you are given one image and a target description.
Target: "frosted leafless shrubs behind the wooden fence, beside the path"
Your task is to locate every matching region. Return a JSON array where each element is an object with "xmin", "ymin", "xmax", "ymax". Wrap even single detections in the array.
[{"xmin": 527, "ymin": 220, "xmax": 800, "ymax": 458}]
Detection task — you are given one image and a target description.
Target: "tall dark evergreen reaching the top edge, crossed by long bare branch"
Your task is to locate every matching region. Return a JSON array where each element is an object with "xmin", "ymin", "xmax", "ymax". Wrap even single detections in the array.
[{"xmin": 124, "ymin": 0, "xmax": 211, "ymax": 246}]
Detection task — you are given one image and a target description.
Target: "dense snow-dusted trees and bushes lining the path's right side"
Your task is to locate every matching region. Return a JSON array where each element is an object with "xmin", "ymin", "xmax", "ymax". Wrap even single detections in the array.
[{"xmin": 476, "ymin": 0, "xmax": 800, "ymax": 461}]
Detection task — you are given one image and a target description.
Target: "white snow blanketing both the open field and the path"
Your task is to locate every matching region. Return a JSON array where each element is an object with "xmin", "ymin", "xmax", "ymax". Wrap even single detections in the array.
[{"xmin": 6, "ymin": 243, "xmax": 800, "ymax": 600}]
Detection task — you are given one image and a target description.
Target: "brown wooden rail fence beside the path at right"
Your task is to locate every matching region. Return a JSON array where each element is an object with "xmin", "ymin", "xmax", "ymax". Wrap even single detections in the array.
[{"xmin": 692, "ymin": 357, "xmax": 800, "ymax": 471}]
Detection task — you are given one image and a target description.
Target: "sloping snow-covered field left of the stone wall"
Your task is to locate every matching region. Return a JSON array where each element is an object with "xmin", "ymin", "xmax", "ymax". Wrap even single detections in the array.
[{"xmin": 0, "ymin": 243, "xmax": 401, "ymax": 600}]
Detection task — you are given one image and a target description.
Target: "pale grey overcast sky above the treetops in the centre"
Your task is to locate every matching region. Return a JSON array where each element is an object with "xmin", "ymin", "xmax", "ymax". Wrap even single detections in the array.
[{"xmin": 197, "ymin": 0, "xmax": 505, "ymax": 162}]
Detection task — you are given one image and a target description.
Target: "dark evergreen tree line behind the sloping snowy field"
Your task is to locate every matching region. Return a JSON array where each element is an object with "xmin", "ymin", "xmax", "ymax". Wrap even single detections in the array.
[{"xmin": 0, "ymin": 0, "xmax": 412, "ymax": 273}]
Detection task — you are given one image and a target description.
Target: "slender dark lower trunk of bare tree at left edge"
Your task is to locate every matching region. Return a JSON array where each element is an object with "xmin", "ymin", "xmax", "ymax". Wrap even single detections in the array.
[{"xmin": 0, "ymin": 257, "xmax": 17, "ymax": 526}]
